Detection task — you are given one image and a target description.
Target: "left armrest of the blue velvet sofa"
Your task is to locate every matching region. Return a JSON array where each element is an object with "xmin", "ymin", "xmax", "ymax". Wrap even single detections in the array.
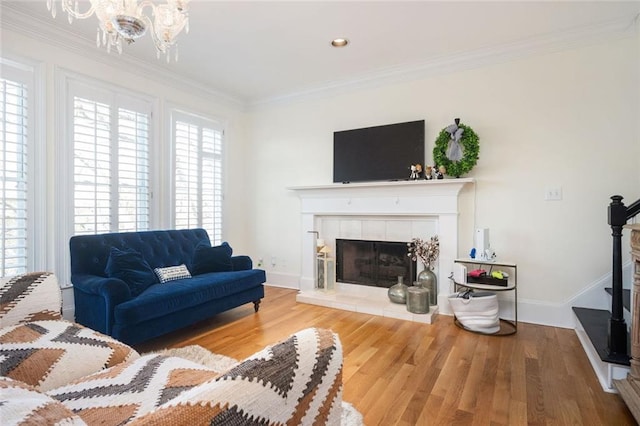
[{"xmin": 71, "ymin": 274, "xmax": 131, "ymax": 335}]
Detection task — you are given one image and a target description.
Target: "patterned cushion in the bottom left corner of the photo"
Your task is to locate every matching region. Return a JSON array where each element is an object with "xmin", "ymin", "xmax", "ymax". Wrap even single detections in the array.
[{"xmin": 0, "ymin": 377, "xmax": 86, "ymax": 425}]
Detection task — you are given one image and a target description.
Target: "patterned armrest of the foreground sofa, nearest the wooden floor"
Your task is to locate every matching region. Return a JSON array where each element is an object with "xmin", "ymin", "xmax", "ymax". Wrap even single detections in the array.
[{"xmin": 131, "ymin": 328, "xmax": 342, "ymax": 425}]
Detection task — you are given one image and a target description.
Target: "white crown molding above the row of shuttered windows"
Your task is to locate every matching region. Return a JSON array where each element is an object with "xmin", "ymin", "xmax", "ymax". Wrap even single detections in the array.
[{"xmin": 0, "ymin": 2, "xmax": 246, "ymax": 109}]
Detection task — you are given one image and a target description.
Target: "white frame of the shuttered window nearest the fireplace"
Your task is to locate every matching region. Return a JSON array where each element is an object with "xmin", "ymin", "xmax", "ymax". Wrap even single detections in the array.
[{"xmin": 168, "ymin": 107, "xmax": 226, "ymax": 245}]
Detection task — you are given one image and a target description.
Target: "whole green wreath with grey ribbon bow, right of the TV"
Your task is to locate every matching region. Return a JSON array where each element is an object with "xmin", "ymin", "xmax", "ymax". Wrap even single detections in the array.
[{"xmin": 433, "ymin": 118, "xmax": 480, "ymax": 177}]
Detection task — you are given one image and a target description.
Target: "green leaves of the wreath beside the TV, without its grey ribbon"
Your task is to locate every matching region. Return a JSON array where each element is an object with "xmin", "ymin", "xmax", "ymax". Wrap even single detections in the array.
[{"xmin": 433, "ymin": 124, "xmax": 480, "ymax": 178}]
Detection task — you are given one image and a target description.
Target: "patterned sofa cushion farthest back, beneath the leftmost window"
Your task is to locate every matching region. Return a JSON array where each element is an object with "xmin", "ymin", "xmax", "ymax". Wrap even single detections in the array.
[{"xmin": 0, "ymin": 272, "xmax": 62, "ymax": 327}]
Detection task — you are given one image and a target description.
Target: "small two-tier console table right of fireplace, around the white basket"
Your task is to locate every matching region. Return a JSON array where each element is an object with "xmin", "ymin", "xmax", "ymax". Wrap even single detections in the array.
[{"xmin": 451, "ymin": 258, "xmax": 518, "ymax": 336}]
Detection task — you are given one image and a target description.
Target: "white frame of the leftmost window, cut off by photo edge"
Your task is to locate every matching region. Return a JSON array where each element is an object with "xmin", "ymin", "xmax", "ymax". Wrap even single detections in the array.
[{"xmin": 0, "ymin": 56, "xmax": 44, "ymax": 276}]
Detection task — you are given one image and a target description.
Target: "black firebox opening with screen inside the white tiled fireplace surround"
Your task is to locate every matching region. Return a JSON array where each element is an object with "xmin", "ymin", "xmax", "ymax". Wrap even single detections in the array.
[{"xmin": 336, "ymin": 238, "xmax": 416, "ymax": 288}]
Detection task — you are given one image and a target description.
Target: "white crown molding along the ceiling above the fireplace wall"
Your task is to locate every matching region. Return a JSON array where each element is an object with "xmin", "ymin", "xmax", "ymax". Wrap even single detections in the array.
[{"xmin": 248, "ymin": 14, "xmax": 640, "ymax": 109}]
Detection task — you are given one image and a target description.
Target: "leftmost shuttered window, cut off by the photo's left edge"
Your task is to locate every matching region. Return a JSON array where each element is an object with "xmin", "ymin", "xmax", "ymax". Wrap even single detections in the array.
[{"xmin": 0, "ymin": 58, "xmax": 44, "ymax": 276}]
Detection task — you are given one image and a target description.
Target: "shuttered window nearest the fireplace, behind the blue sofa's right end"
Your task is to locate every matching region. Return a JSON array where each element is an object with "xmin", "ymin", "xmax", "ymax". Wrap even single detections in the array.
[{"xmin": 172, "ymin": 112, "xmax": 224, "ymax": 244}]
